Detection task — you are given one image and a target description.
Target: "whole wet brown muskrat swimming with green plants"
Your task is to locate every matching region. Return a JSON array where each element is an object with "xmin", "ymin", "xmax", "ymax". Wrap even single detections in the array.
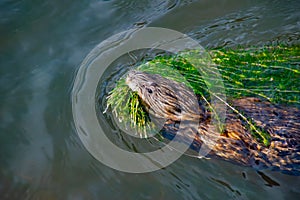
[{"xmin": 126, "ymin": 70, "xmax": 300, "ymax": 175}]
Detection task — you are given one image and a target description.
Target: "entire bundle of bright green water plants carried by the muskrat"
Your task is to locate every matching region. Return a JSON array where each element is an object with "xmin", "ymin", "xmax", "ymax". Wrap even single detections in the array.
[{"xmin": 107, "ymin": 46, "xmax": 300, "ymax": 145}]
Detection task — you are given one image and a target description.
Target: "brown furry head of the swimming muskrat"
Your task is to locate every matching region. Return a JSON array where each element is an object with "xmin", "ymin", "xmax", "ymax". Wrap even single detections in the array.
[{"xmin": 126, "ymin": 70, "xmax": 201, "ymax": 121}]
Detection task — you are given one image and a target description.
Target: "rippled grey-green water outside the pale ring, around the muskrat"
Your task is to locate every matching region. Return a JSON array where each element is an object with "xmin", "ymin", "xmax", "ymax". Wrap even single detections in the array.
[{"xmin": 0, "ymin": 0, "xmax": 300, "ymax": 199}]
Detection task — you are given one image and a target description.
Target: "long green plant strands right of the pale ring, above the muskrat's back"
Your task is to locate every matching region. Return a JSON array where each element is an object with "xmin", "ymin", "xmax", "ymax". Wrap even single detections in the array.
[{"xmin": 210, "ymin": 46, "xmax": 300, "ymax": 104}]
